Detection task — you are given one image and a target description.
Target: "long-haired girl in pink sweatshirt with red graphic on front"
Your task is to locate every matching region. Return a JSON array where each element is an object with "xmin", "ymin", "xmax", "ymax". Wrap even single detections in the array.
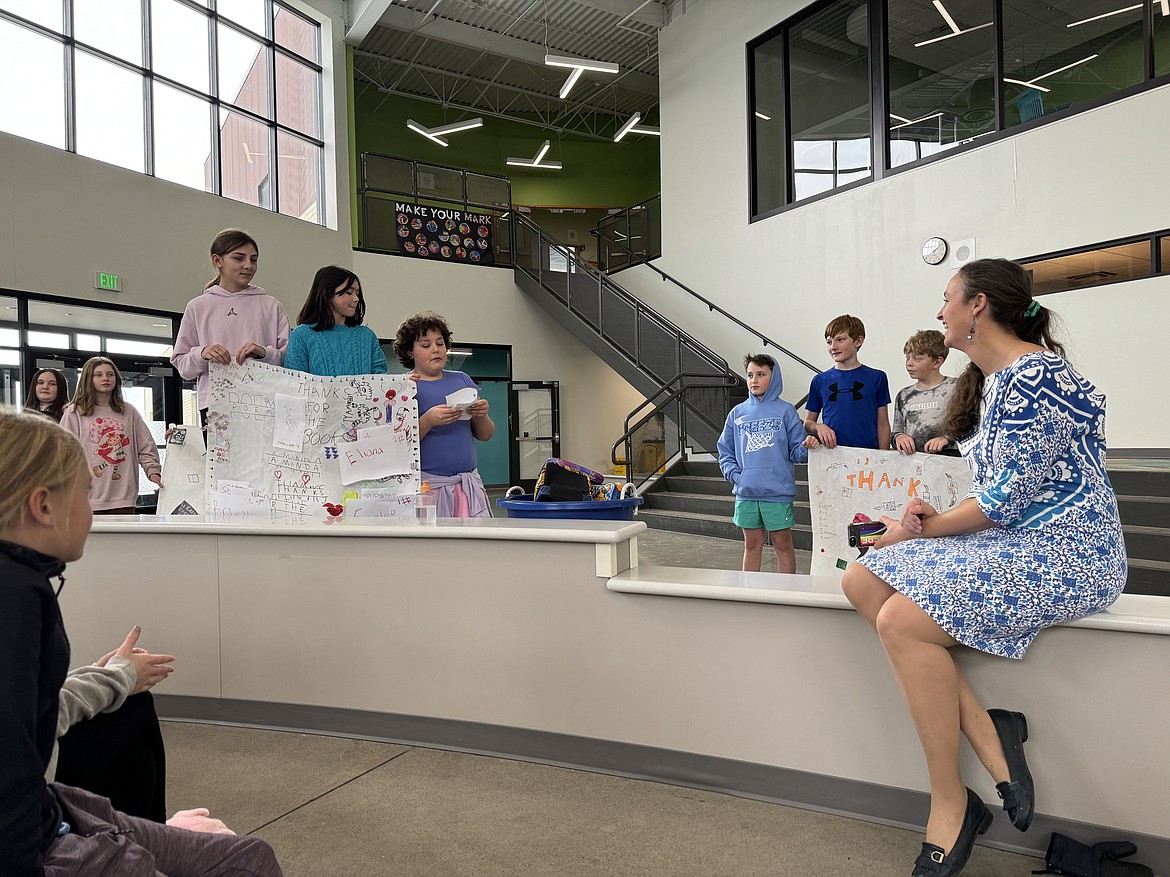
[{"xmin": 61, "ymin": 357, "xmax": 163, "ymax": 515}]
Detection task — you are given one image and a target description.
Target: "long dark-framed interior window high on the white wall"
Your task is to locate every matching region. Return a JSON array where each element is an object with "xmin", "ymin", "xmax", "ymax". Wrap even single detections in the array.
[{"xmin": 748, "ymin": 0, "xmax": 1170, "ymax": 219}]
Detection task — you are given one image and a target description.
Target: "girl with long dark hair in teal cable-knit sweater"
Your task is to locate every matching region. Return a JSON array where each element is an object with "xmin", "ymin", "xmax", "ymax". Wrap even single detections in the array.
[{"xmin": 284, "ymin": 265, "xmax": 386, "ymax": 378}]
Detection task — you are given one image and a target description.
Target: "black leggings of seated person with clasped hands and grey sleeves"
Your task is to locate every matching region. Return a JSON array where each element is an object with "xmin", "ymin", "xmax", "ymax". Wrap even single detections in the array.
[{"xmin": 56, "ymin": 691, "xmax": 166, "ymax": 822}]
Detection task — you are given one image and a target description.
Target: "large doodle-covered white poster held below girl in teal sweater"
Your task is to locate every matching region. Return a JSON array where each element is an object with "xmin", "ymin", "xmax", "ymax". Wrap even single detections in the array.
[{"xmin": 206, "ymin": 360, "xmax": 419, "ymax": 524}]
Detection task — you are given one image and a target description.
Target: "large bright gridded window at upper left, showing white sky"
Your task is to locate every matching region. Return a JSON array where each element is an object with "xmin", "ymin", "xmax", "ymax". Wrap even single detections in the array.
[{"xmin": 0, "ymin": 0, "xmax": 325, "ymax": 223}]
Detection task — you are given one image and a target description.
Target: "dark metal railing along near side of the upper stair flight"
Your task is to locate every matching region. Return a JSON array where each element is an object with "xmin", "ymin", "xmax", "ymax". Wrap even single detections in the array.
[{"xmin": 512, "ymin": 213, "xmax": 739, "ymax": 427}]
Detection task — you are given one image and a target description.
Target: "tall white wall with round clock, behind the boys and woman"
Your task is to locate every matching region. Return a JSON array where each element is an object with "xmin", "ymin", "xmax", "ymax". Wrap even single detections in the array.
[{"xmin": 659, "ymin": 0, "xmax": 1170, "ymax": 448}]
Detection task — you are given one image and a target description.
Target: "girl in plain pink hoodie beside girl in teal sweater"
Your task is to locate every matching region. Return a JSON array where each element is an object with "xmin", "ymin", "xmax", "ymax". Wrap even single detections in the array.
[{"xmin": 171, "ymin": 228, "xmax": 289, "ymax": 410}]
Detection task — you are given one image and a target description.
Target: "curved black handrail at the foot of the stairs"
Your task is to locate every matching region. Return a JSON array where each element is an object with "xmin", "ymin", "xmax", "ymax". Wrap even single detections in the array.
[{"xmin": 610, "ymin": 373, "xmax": 742, "ymax": 489}]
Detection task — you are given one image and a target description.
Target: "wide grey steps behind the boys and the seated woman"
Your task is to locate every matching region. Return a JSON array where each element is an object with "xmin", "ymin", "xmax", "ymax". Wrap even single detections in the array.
[{"xmin": 639, "ymin": 460, "xmax": 1170, "ymax": 596}]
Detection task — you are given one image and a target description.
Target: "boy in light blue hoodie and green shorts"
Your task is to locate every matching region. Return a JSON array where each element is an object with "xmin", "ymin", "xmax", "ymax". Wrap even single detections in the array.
[{"xmin": 718, "ymin": 353, "xmax": 819, "ymax": 573}]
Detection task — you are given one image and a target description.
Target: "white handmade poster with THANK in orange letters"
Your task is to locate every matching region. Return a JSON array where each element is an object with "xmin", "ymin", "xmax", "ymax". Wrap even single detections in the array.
[{"xmin": 808, "ymin": 447, "xmax": 971, "ymax": 584}]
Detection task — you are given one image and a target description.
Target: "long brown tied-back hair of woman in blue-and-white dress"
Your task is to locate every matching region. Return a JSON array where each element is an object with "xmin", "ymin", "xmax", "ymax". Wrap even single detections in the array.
[{"xmin": 943, "ymin": 258, "xmax": 1065, "ymax": 439}]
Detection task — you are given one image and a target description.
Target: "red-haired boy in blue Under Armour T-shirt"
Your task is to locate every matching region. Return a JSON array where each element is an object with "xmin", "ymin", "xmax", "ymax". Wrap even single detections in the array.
[{"xmin": 804, "ymin": 313, "xmax": 889, "ymax": 449}]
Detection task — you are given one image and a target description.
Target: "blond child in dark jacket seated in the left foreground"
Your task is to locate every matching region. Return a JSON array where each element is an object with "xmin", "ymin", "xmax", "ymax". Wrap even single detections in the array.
[{"xmin": 0, "ymin": 409, "xmax": 281, "ymax": 877}]
